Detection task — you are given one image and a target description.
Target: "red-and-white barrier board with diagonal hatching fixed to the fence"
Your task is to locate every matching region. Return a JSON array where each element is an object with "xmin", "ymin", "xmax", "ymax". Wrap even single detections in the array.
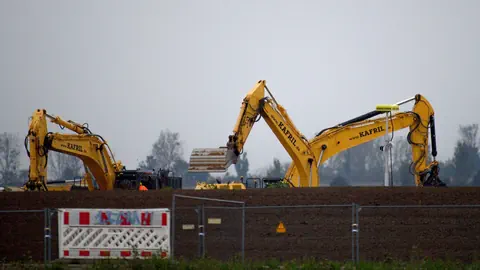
[{"xmin": 58, "ymin": 208, "xmax": 170, "ymax": 259}]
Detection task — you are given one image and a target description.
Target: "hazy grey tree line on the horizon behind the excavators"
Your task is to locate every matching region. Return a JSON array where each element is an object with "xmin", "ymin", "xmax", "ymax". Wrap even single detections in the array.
[{"xmin": 0, "ymin": 124, "xmax": 480, "ymax": 188}]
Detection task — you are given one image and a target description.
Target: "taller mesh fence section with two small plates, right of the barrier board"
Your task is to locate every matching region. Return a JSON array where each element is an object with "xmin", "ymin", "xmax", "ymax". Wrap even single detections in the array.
[{"xmin": 171, "ymin": 194, "xmax": 245, "ymax": 260}]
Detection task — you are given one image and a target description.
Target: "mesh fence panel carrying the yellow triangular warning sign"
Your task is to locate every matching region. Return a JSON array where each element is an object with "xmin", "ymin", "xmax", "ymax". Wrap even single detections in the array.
[{"xmin": 245, "ymin": 204, "xmax": 355, "ymax": 261}]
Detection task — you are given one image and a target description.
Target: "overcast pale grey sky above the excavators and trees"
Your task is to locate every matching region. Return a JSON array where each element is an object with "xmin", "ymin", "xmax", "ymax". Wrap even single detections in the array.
[{"xmin": 0, "ymin": 0, "xmax": 480, "ymax": 176}]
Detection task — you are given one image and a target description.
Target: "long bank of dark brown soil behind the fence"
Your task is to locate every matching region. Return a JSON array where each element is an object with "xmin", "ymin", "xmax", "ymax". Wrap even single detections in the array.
[{"xmin": 0, "ymin": 187, "xmax": 480, "ymax": 261}]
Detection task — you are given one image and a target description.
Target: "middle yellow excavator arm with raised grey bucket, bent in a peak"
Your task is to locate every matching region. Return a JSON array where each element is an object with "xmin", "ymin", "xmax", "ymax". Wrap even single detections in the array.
[{"xmin": 189, "ymin": 80, "xmax": 318, "ymax": 186}]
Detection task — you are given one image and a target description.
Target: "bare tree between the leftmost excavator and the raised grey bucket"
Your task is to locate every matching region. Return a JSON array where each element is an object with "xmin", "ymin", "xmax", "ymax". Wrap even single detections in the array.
[{"xmin": 139, "ymin": 129, "xmax": 183, "ymax": 170}]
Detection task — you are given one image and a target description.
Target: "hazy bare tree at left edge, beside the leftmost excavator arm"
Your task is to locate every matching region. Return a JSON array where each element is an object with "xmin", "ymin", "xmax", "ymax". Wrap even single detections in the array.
[{"xmin": 0, "ymin": 132, "xmax": 20, "ymax": 185}]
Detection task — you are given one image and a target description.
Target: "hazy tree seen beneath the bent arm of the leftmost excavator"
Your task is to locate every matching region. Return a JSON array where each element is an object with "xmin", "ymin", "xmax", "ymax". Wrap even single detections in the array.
[{"xmin": 48, "ymin": 151, "xmax": 85, "ymax": 180}]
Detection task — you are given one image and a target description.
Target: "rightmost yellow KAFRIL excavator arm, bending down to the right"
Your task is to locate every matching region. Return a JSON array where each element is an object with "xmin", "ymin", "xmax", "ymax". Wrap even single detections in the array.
[{"xmin": 285, "ymin": 95, "xmax": 445, "ymax": 187}]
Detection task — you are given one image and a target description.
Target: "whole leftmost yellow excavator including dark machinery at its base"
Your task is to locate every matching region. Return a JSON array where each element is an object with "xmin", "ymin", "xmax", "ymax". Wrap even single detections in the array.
[{"xmin": 24, "ymin": 109, "xmax": 181, "ymax": 191}]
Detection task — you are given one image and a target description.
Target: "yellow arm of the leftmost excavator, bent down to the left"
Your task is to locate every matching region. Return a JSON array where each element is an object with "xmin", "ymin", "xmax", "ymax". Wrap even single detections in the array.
[{"xmin": 25, "ymin": 109, "xmax": 124, "ymax": 190}]
